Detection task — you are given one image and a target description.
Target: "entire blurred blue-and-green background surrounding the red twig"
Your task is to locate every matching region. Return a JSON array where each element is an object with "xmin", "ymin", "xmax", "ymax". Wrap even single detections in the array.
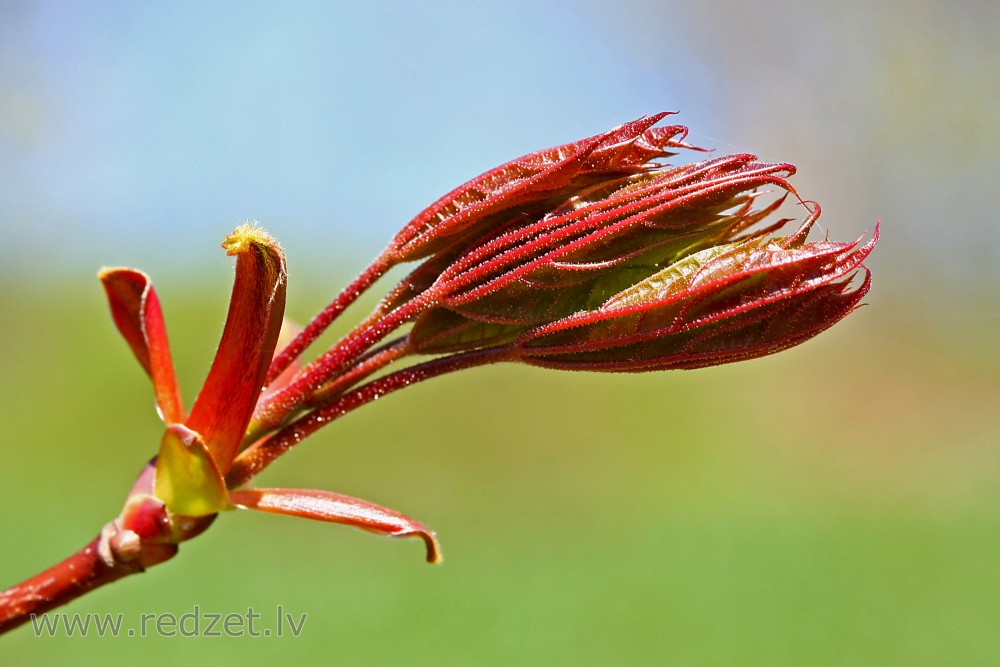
[{"xmin": 0, "ymin": 0, "xmax": 1000, "ymax": 665}]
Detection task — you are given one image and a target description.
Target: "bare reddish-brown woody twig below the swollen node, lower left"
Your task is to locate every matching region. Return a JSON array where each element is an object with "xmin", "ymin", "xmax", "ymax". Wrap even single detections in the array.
[{"xmin": 0, "ymin": 535, "xmax": 136, "ymax": 634}]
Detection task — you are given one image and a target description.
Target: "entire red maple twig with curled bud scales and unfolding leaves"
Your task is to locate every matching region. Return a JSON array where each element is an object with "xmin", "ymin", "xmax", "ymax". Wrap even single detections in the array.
[{"xmin": 0, "ymin": 114, "xmax": 878, "ymax": 630}]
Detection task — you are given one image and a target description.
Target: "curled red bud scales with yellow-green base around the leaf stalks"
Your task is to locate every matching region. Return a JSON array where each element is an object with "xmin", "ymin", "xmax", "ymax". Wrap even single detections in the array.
[{"xmin": 101, "ymin": 225, "xmax": 439, "ymax": 561}]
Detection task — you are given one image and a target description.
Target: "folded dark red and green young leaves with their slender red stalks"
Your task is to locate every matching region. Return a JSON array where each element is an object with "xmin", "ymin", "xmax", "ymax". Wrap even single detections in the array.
[{"xmin": 232, "ymin": 114, "xmax": 878, "ymax": 488}]
